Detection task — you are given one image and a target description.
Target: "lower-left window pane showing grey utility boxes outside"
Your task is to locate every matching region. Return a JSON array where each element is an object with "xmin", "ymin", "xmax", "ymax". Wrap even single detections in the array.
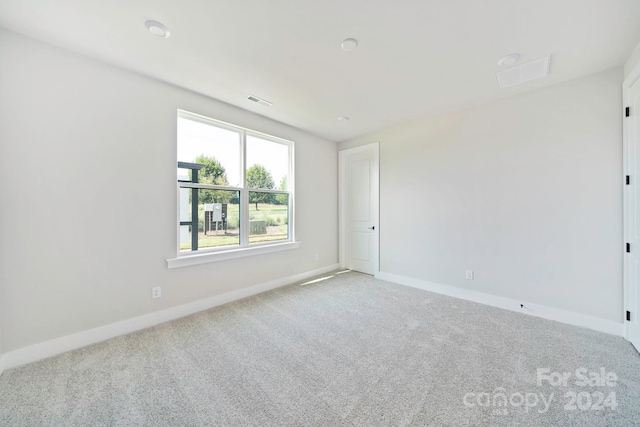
[{"xmin": 180, "ymin": 188, "xmax": 240, "ymax": 251}]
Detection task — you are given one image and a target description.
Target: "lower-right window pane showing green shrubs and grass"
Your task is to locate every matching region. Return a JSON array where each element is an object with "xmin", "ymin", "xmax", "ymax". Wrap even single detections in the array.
[{"xmin": 249, "ymin": 191, "xmax": 289, "ymax": 243}]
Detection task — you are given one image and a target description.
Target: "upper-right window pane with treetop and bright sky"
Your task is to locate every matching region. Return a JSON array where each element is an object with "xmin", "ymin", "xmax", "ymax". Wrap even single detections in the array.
[{"xmin": 247, "ymin": 135, "xmax": 289, "ymax": 191}]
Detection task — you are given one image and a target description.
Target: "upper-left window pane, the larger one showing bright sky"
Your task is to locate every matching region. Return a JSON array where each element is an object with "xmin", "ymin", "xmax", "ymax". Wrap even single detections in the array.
[{"xmin": 178, "ymin": 117, "xmax": 241, "ymax": 187}]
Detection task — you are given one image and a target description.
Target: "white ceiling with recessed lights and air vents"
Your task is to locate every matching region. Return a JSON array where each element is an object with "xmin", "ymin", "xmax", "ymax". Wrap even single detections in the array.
[{"xmin": 0, "ymin": 0, "xmax": 640, "ymax": 142}]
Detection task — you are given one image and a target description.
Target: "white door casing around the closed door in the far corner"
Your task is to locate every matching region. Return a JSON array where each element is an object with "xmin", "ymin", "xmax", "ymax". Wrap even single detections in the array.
[{"xmin": 338, "ymin": 142, "xmax": 380, "ymax": 277}]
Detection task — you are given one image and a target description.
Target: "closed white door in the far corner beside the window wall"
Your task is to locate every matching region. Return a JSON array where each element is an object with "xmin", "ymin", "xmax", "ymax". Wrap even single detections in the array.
[{"xmin": 340, "ymin": 143, "xmax": 379, "ymax": 275}]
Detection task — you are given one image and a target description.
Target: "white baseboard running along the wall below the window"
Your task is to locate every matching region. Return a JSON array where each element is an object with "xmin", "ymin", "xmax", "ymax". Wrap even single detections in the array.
[{"xmin": 0, "ymin": 264, "xmax": 340, "ymax": 373}]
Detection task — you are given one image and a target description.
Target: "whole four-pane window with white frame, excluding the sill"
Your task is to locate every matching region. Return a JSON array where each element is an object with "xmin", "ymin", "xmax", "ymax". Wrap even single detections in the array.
[{"xmin": 170, "ymin": 111, "xmax": 293, "ymax": 261}]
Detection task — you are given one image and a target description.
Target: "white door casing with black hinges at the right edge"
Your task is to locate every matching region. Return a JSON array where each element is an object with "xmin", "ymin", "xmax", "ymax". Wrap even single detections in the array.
[{"xmin": 620, "ymin": 63, "xmax": 640, "ymax": 341}]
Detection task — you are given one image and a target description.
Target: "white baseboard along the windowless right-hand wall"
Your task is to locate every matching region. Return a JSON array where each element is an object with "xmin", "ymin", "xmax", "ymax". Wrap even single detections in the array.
[{"xmin": 376, "ymin": 272, "xmax": 624, "ymax": 336}]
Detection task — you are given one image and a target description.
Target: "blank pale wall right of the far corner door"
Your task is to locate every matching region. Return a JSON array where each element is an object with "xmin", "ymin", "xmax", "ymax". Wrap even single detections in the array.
[{"xmin": 340, "ymin": 68, "xmax": 623, "ymax": 322}]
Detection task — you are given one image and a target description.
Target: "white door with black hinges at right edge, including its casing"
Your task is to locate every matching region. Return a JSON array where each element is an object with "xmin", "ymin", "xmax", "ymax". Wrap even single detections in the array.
[{"xmin": 625, "ymin": 74, "xmax": 640, "ymax": 351}]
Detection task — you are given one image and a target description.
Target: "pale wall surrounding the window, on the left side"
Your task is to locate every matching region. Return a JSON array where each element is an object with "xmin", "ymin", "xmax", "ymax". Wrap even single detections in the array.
[{"xmin": 0, "ymin": 31, "xmax": 338, "ymax": 352}]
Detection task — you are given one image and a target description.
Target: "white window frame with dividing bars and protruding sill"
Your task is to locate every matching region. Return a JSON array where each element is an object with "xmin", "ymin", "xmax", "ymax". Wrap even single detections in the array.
[{"xmin": 167, "ymin": 110, "xmax": 300, "ymax": 268}]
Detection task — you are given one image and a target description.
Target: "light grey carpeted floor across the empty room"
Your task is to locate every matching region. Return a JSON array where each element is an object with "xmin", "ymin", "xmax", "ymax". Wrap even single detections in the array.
[{"xmin": 0, "ymin": 272, "xmax": 640, "ymax": 426}]
